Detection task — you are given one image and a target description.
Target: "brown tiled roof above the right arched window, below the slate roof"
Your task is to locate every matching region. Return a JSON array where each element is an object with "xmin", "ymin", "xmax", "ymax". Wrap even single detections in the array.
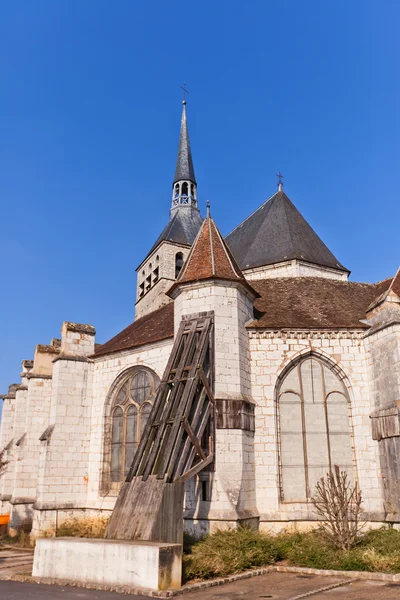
[{"xmin": 248, "ymin": 277, "xmax": 392, "ymax": 329}]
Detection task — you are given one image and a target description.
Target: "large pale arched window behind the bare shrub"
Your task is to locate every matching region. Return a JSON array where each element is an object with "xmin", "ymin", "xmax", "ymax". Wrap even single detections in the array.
[{"xmin": 277, "ymin": 356, "xmax": 354, "ymax": 502}]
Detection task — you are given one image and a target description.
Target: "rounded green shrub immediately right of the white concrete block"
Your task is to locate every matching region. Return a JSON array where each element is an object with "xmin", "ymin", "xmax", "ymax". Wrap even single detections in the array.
[{"xmin": 184, "ymin": 527, "xmax": 279, "ymax": 580}]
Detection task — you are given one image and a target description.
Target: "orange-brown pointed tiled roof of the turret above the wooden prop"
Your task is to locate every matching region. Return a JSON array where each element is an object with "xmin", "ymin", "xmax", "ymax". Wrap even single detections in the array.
[{"xmin": 169, "ymin": 215, "xmax": 258, "ymax": 297}]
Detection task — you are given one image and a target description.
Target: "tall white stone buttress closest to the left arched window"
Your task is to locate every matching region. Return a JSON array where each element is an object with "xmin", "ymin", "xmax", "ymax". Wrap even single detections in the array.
[{"xmin": 32, "ymin": 322, "xmax": 95, "ymax": 536}]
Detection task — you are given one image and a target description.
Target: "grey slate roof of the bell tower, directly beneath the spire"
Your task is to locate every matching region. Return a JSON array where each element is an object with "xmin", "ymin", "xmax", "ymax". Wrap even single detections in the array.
[{"xmin": 142, "ymin": 205, "xmax": 203, "ymax": 262}]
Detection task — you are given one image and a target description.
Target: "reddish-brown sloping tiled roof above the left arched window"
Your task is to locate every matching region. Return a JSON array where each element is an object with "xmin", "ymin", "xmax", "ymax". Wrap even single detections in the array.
[{"xmin": 92, "ymin": 302, "xmax": 174, "ymax": 358}]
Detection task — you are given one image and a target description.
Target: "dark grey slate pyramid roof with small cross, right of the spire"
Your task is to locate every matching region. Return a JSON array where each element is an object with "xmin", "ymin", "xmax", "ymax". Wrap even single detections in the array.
[{"xmin": 225, "ymin": 191, "xmax": 348, "ymax": 272}]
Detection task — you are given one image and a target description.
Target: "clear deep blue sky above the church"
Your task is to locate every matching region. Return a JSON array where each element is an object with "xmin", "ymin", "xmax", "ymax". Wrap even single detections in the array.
[{"xmin": 0, "ymin": 0, "xmax": 400, "ymax": 393}]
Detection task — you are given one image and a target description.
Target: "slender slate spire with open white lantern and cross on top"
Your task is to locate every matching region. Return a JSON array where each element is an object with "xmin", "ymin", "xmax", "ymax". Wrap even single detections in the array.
[{"xmin": 172, "ymin": 98, "xmax": 197, "ymax": 208}]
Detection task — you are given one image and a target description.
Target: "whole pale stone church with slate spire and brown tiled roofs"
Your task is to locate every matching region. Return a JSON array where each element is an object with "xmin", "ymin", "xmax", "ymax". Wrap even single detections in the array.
[{"xmin": 0, "ymin": 101, "xmax": 400, "ymax": 538}]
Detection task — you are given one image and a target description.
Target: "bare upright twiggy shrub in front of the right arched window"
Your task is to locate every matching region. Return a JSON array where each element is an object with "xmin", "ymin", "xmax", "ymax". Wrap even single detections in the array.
[{"xmin": 312, "ymin": 465, "xmax": 364, "ymax": 550}]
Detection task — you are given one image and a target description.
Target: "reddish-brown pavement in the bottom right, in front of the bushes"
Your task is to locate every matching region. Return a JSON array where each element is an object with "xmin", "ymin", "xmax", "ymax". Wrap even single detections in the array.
[{"xmin": 189, "ymin": 572, "xmax": 400, "ymax": 600}]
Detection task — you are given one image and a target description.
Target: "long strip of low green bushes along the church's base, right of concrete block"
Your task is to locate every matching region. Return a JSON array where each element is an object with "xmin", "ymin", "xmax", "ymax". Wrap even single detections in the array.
[{"xmin": 183, "ymin": 528, "xmax": 400, "ymax": 580}]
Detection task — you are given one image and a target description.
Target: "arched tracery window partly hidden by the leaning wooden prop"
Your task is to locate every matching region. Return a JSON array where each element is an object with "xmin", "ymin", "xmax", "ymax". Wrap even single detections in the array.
[{"xmin": 108, "ymin": 367, "xmax": 159, "ymax": 488}]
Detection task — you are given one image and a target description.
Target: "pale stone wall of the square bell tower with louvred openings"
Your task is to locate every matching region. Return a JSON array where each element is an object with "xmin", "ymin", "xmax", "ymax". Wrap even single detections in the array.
[{"xmin": 135, "ymin": 242, "xmax": 190, "ymax": 319}]
